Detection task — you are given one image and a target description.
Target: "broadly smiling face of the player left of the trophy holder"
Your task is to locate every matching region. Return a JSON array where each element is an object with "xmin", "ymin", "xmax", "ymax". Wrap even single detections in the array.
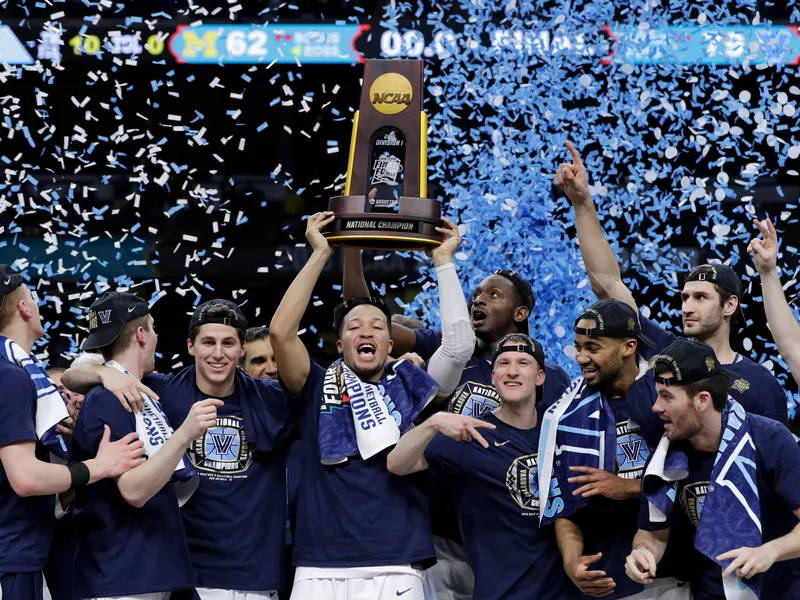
[{"xmin": 187, "ymin": 323, "xmax": 244, "ymax": 386}]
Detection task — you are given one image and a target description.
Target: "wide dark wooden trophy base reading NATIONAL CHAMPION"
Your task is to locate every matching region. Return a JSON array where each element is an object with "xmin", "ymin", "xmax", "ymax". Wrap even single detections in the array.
[{"xmin": 323, "ymin": 196, "xmax": 443, "ymax": 250}]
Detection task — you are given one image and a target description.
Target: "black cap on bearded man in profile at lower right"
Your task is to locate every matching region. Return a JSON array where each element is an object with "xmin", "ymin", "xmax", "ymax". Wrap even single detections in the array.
[{"xmin": 651, "ymin": 338, "xmax": 739, "ymax": 385}]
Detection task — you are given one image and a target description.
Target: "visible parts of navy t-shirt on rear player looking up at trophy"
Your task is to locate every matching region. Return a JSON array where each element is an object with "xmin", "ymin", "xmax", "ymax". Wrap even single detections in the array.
[{"xmin": 414, "ymin": 329, "xmax": 569, "ymax": 542}]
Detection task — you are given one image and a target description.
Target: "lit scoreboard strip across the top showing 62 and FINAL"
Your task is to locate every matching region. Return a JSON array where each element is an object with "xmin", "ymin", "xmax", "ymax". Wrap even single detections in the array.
[{"xmin": 0, "ymin": 17, "xmax": 800, "ymax": 65}]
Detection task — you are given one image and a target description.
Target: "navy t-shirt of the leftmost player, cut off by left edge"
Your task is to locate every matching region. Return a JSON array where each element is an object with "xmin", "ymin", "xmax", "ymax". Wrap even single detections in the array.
[{"xmin": 0, "ymin": 360, "xmax": 55, "ymax": 573}]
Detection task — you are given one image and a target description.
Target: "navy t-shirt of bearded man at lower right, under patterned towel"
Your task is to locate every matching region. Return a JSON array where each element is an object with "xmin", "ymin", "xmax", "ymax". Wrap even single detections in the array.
[{"xmin": 639, "ymin": 415, "xmax": 800, "ymax": 600}]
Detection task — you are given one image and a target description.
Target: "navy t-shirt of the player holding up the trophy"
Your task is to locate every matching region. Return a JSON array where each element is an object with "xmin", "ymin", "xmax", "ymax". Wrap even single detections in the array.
[{"xmin": 290, "ymin": 361, "xmax": 434, "ymax": 568}]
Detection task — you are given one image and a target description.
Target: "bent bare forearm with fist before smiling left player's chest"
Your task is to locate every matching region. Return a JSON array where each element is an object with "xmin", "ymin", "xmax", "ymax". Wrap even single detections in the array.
[{"xmin": 117, "ymin": 398, "xmax": 217, "ymax": 508}]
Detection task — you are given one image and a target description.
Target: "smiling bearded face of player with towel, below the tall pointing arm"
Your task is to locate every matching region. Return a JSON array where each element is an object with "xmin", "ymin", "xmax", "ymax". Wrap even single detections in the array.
[{"xmin": 575, "ymin": 319, "xmax": 636, "ymax": 387}]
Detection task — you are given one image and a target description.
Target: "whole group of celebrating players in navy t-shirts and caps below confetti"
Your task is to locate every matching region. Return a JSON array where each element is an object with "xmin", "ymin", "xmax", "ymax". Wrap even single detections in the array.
[{"xmin": 0, "ymin": 144, "xmax": 800, "ymax": 600}]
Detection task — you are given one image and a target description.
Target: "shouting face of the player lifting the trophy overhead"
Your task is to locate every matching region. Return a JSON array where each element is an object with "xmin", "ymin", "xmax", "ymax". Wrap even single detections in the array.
[{"xmin": 336, "ymin": 304, "xmax": 393, "ymax": 381}]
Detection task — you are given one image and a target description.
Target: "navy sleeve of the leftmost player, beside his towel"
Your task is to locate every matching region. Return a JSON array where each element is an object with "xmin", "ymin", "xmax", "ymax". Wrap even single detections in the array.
[{"xmin": 0, "ymin": 364, "xmax": 39, "ymax": 447}]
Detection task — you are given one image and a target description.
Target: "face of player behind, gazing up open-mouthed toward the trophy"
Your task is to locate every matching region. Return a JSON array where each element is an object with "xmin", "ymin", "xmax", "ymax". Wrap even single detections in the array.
[{"xmin": 470, "ymin": 275, "xmax": 529, "ymax": 344}]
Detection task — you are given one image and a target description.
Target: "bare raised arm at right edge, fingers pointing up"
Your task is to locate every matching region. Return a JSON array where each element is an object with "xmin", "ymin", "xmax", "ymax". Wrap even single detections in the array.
[{"xmin": 747, "ymin": 219, "xmax": 800, "ymax": 383}]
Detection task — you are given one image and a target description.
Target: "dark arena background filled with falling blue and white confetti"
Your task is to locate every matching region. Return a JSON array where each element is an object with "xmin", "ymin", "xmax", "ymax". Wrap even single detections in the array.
[{"xmin": 0, "ymin": 0, "xmax": 800, "ymax": 422}]
